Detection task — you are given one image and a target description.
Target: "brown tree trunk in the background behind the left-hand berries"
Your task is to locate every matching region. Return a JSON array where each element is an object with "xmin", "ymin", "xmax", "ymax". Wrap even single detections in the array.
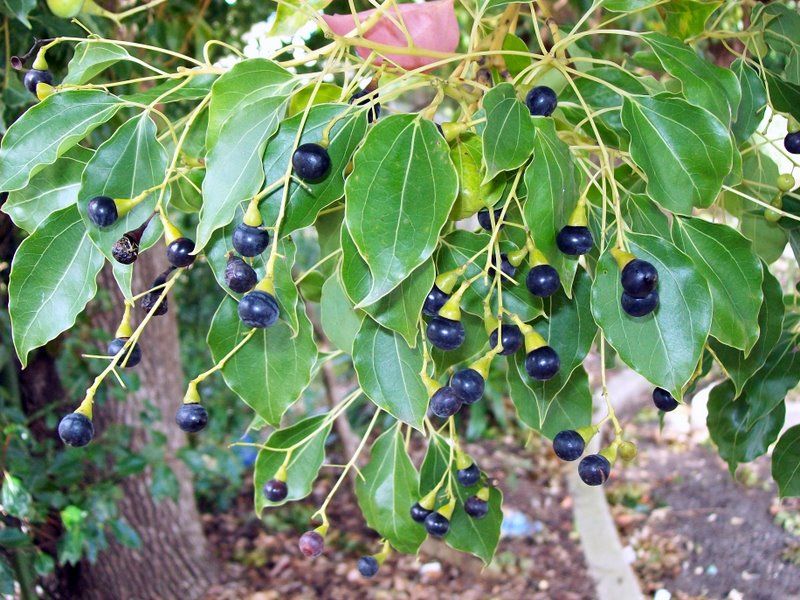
[{"xmin": 75, "ymin": 246, "xmax": 219, "ymax": 600}]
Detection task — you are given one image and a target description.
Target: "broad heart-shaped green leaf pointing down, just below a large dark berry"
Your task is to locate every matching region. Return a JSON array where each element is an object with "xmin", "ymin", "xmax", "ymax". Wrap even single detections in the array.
[{"xmin": 207, "ymin": 298, "xmax": 317, "ymax": 425}]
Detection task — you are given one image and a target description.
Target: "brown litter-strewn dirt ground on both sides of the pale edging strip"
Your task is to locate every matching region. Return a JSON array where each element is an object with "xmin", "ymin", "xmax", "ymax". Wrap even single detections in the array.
[{"xmin": 200, "ymin": 400, "xmax": 800, "ymax": 600}]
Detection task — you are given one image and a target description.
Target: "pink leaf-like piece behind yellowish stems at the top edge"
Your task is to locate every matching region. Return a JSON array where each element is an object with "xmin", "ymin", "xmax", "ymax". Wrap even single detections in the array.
[{"xmin": 322, "ymin": 0, "xmax": 459, "ymax": 69}]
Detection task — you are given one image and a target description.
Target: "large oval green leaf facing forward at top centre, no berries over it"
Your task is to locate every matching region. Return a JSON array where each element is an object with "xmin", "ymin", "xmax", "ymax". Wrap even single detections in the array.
[{"xmin": 345, "ymin": 115, "xmax": 458, "ymax": 307}]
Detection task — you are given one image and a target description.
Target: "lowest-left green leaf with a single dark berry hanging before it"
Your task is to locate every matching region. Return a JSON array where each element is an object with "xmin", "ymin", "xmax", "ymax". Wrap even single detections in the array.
[{"xmin": 253, "ymin": 414, "xmax": 333, "ymax": 516}]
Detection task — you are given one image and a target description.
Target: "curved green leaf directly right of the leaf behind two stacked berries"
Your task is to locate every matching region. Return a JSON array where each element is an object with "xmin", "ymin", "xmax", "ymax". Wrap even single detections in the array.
[{"xmin": 672, "ymin": 218, "xmax": 764, "ymax": 353}]
